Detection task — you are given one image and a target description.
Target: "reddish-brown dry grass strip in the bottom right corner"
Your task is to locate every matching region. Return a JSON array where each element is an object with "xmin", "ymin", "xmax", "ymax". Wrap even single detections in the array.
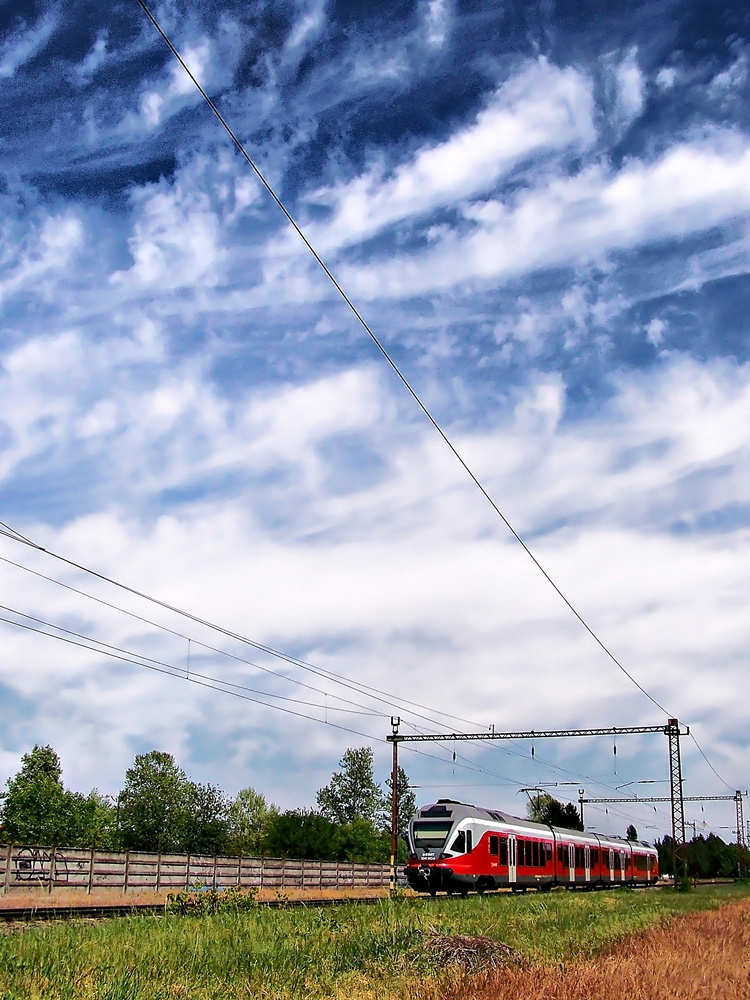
[{"xmin": 445, "ymin": 900, "xmax": 750, "ymax": 1000}]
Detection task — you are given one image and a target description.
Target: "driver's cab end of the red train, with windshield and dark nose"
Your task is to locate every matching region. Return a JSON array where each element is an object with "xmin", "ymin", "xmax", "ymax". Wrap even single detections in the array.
[{"xmin": 404, "ymin": 799, "xmax": 476, "ymax": 896}]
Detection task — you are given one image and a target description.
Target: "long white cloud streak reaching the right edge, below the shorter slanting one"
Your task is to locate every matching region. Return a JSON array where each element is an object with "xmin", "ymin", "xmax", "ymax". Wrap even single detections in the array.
[{"xmin": 341, "ymin": 133, "xmax": 750, "ymax": 298}]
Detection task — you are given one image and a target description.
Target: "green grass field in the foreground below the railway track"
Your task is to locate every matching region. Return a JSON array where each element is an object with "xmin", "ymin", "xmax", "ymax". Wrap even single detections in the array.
[{"xmin": 0, "ymin": 885, "xmax": 750, "ymax": 1000}]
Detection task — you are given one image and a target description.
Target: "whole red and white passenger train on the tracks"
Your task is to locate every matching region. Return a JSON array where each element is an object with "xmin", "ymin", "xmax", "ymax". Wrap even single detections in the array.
[{"xmin": 404, "ymin": 799, "xmax": 659, "ymax": 896}]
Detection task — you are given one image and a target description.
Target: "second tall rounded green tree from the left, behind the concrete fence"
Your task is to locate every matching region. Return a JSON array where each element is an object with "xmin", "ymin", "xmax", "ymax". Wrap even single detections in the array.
[{"xmin": 118, "ymin": 750, "xmax": 190, "ymax": 851}]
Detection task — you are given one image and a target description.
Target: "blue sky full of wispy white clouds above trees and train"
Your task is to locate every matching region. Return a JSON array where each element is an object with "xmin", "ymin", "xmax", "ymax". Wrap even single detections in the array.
[{"xmin": 0, "ymin": 0, "xmax": 750, "ymax": 839}]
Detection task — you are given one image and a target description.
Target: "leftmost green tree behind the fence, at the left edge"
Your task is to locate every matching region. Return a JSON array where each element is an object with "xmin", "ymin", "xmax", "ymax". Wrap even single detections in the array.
[{"xmin": 1, "ymin": 744, "xmax": 77, "ymax": 847}]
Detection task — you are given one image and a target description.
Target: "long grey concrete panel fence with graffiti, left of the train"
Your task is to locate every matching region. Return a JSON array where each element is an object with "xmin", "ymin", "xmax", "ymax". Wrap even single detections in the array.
[{"xmin": 0, "ymin": 844, "xmax": 390, "ymax": 894}]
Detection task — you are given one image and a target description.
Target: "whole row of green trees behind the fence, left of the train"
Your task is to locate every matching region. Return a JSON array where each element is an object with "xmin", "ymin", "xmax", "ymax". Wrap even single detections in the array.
[{"xmin": 0, "ymin": 745, "xmax": 416, "ymax": 863}]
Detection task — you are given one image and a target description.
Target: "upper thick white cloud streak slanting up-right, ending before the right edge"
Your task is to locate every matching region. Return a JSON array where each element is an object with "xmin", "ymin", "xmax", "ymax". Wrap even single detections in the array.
[{"xmin": 296, "ymin": 60, "xmax": 594, "ymax": 251}]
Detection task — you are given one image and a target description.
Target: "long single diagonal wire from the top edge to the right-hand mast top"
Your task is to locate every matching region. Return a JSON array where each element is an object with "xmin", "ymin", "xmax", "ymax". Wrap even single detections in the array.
[{"xmin": 138, "ymin": 0, "xmax": 673, "ymax": 716}]
